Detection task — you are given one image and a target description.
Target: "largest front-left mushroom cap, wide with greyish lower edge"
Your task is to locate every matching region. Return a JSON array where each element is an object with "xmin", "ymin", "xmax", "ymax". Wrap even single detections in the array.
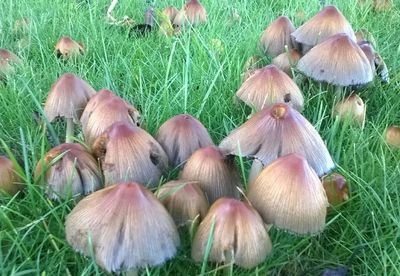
[{"xmin": 65, "ymin": 182, "xmax": 180, "ymax": 272}]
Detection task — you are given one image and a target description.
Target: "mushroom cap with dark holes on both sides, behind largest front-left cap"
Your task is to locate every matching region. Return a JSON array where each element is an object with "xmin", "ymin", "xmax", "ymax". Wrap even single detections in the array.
[{"xmin": 92, "ymin": 122, "xmax": 168, "ymax": 187}]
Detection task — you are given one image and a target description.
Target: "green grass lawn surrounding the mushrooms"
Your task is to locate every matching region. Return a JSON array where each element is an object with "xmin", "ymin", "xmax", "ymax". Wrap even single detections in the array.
[{"xmin": 0, "ymin": 0, "xmax": 400, "ymax": 275}]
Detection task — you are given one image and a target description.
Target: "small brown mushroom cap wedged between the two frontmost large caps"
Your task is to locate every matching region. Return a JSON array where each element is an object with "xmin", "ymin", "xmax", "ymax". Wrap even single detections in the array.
[{"xmin": 157, "ymin": 180, "xmax": 208, "ymax": 226}]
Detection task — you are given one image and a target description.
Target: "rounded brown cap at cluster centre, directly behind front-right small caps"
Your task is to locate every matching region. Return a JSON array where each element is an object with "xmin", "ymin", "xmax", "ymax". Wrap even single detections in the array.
[{"xmin": 181, "ymin": 146, "xmax": 241, "ymax": 203}]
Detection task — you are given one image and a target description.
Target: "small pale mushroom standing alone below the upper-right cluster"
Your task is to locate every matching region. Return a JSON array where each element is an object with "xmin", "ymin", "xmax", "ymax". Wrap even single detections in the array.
[{"xmin": 334, "ymin": 93, "xmax": 366, "ymax": 126}]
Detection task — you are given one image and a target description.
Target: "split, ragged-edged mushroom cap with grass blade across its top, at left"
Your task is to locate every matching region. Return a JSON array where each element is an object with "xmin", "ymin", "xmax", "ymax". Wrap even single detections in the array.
[{"xmin": 35, "ymin": 144, "xmax": 103, "ymax": 199}]
